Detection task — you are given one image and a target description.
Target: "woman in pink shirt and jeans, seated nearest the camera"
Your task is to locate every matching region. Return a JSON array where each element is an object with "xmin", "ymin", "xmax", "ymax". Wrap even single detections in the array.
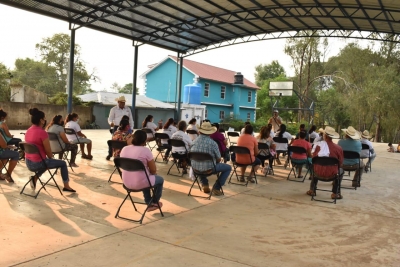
[{"xmin": 120, "ymin": 130, "xmax": 164, "ymax": 211}]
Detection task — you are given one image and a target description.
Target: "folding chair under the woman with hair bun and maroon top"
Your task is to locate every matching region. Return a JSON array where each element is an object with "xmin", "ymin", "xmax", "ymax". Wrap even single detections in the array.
[{"xmin": 19, "ymin": 142, "xmax": 63, "ymax": 198}]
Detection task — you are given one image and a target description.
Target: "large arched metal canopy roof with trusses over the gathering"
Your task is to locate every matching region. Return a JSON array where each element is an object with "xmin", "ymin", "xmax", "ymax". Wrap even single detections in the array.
[{"xmin": 0, "ymin": 0, "xmax": 400, "ymax": 55}]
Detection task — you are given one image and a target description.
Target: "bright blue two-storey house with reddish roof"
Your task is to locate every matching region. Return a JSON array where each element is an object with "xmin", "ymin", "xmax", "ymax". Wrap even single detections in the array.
[{"xmin": 141, "ymin": 56, "xmax": 259, "ymax": 122}]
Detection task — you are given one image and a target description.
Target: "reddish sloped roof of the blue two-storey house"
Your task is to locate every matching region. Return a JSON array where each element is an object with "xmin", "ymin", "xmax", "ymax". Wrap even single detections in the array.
[{"xmin": 169, "ymin": 56, "xmax": 260, "ymax": 89}]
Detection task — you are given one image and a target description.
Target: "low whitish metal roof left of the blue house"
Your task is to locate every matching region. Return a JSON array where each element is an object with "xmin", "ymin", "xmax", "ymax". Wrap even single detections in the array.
[{"xmin": 78, "ymin": 92, "xmax": 175, "ymax": 109}]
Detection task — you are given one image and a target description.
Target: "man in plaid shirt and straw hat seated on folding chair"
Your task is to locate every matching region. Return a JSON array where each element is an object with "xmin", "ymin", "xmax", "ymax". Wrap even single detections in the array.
[{"xmin": 190, "ymin": 122, "xmax": 232, "ymax": 196}]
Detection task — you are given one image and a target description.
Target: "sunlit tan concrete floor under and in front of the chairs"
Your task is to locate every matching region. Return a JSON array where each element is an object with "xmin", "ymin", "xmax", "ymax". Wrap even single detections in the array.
[{"xmin": 0, "ymin": 130, "xmax": 400, "ymax": 266}]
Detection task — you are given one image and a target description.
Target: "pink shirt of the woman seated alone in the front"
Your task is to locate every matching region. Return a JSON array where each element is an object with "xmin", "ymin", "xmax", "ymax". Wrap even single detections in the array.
[{"xmin": 120, "ymin": 145, "xmax": 156, "ymax": 189}]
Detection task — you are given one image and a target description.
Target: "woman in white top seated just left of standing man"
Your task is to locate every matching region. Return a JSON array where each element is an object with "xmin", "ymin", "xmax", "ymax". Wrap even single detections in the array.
[{"xmin": 65, "ymin": 113, "xmax": 93, "ymax": 160}]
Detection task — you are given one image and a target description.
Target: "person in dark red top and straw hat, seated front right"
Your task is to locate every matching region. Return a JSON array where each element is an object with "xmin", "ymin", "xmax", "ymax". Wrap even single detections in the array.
[{"xmin": 307, "ymin": 126, "xmax": 344, "ymax": 199}]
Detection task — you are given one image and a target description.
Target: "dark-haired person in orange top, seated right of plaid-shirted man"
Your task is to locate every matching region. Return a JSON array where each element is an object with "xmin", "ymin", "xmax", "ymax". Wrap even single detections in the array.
[{"xmin": 235, "ymin": 124, "xmax": 261, "ymax": 183}]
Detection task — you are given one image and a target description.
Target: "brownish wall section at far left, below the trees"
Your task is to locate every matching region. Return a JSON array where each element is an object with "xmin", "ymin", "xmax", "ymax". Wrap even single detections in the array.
[{"xmin": 10, "ymin": 85, "xmax": 49, "ymax": 104}]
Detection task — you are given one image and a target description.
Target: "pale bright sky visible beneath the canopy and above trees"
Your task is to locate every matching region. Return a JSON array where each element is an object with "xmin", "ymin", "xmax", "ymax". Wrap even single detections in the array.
[{"xmin": 0, "ymin": 4, "xmax": 360, "ymax": 94}]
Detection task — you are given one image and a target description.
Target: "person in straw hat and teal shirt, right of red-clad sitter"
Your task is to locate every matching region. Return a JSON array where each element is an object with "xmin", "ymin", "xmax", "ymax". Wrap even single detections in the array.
[{"xmin": 338, "ymin": 126, "xmax": 364, "ymax": 187}]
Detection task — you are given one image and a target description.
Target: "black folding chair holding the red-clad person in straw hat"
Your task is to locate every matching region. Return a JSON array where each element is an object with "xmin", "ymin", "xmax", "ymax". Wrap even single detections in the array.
[{"xmin": 311, "ymin": 157, "xmax": 340, "ymax": 204}]
